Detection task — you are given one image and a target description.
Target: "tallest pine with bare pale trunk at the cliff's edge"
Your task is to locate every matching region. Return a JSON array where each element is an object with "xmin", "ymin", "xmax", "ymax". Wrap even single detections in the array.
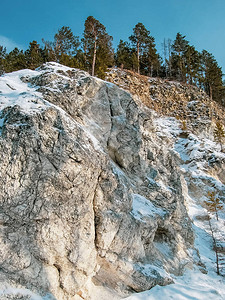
[{"xmin": 82, "ymin": 16, "xmax": 113, "ymax": 78}]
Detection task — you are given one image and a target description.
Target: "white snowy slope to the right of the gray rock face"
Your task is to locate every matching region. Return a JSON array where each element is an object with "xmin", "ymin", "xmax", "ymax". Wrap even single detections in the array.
[{"xmin": 126, "ymin": 118, "xmax": 225, "ymax": 300}]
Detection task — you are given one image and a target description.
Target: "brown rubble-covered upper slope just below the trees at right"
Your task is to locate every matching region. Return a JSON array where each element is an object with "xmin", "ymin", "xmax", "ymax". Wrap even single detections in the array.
[{"xmin": 106, "ymin": 69, "xmax": 225, "ymax": 131}]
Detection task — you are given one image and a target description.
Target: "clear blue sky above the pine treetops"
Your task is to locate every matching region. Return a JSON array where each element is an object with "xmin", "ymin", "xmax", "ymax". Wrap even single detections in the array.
[{"xmin": 0, "ymin": 0, "xmax": 225, "ymax": 73}]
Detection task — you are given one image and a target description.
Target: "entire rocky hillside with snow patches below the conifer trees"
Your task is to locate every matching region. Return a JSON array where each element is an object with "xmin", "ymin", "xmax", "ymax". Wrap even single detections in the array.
[{"xmin": 0, "ymin": 63, "xmax": 225, "ymax": 300}]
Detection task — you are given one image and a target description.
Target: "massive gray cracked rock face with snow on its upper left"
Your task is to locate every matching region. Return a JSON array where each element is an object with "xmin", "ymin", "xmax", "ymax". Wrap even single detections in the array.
[{"xmin": 0, "ymin": 63, "xmax": 193, "ymax": 300}]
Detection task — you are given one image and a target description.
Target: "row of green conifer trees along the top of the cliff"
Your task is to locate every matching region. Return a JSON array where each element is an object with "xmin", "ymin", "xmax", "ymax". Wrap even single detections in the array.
[{"xmin": 0, "ymin": 16, "xmax": 225, "ymax": 105}]
